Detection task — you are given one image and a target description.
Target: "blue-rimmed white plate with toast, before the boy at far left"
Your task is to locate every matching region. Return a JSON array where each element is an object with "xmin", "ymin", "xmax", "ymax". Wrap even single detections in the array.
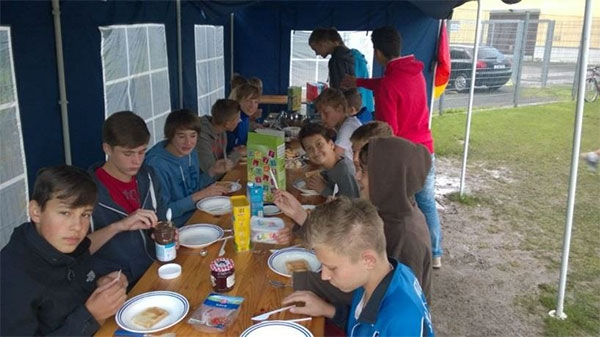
[{"xmin": 115, "ymin": 291, "xmax": 190, "ymax": 333}]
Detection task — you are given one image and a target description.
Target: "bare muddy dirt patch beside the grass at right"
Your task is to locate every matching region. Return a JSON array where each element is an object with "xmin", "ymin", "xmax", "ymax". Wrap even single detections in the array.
[{"xmin": 431, "ymin": 158, "xmax": 558, "ymax": 337}]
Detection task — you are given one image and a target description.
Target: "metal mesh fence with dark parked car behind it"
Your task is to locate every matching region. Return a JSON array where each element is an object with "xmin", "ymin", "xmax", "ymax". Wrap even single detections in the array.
[{"xmin": 433, "ymin": 15, "xmax": 600, "ymax": 114}]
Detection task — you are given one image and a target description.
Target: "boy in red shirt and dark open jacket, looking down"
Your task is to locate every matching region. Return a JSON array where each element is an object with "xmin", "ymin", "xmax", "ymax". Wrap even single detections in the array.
[{"xmin": 88, "ymin": 111, "xmax": 167, "ymax": 288}]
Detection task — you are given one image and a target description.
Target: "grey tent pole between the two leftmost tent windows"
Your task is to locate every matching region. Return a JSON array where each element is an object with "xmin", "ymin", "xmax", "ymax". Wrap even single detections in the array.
[{"xmin": 52, "ymin": 0, "xmax": 73, "ymax": 165}]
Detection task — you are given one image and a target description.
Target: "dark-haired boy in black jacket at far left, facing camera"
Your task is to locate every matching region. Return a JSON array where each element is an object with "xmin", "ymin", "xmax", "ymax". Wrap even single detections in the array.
[{"xmin": 0, "ymin": 166, "xmax": 127, "ymax": 336}]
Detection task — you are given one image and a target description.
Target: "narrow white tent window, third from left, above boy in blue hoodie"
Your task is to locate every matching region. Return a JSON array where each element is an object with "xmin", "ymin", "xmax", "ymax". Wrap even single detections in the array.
[{"xmin": 194, "ymin": 25, "xmax": 225, "ymax": 116}]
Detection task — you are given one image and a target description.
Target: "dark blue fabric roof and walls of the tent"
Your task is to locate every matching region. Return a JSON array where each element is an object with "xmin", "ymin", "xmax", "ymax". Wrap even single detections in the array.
[{"xmin": 0, "ymin": 0, "xmax": 464, "ymax": 189}]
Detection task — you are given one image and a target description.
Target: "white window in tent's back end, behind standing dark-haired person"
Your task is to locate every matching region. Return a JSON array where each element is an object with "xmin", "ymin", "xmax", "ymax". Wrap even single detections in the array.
[{"xmin": 290, "ymin": 30, "xmax": 373, "ymax": 90}]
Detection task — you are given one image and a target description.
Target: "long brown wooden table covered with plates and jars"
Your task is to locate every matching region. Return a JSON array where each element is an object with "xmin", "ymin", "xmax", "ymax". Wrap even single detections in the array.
[{"xmin": 96, "ymin": 161, "xmax": 324, "ymax": 337}]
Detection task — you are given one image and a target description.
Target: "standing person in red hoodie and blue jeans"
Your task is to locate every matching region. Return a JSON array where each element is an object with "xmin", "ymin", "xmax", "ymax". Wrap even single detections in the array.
[{"xmin": 341, "ymin": 27, "xmax": 442, "ymax": 268}]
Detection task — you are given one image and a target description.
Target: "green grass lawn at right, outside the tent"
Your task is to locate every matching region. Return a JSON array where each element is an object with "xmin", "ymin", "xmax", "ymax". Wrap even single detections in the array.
[{"xmin": 432, "ymin": 98, "xmax": 600, "ymax": 336}]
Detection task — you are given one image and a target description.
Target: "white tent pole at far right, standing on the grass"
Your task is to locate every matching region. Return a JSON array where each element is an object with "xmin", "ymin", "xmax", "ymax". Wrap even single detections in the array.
[{"xmin": 549, "ymin": 0, "xmax": 592, "ymax": 319}]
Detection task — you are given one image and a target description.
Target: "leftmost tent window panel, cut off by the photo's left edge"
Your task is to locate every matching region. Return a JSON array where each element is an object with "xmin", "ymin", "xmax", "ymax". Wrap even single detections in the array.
[{"xmin": 0, "ymin": 27, "xmax": 29, "ymax": 248}]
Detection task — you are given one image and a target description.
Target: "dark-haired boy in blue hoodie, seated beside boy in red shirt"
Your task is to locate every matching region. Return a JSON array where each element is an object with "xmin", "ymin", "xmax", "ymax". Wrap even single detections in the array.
[{"xmin": 144, "ymin": 109, "xmax": 234, "ymax": 227}]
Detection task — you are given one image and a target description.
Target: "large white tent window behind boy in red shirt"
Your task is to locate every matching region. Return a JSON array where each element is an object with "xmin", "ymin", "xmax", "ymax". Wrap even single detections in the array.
[{"xmin": 100, "ymin": 24, "xmax": 171, "ymax": 145}]
